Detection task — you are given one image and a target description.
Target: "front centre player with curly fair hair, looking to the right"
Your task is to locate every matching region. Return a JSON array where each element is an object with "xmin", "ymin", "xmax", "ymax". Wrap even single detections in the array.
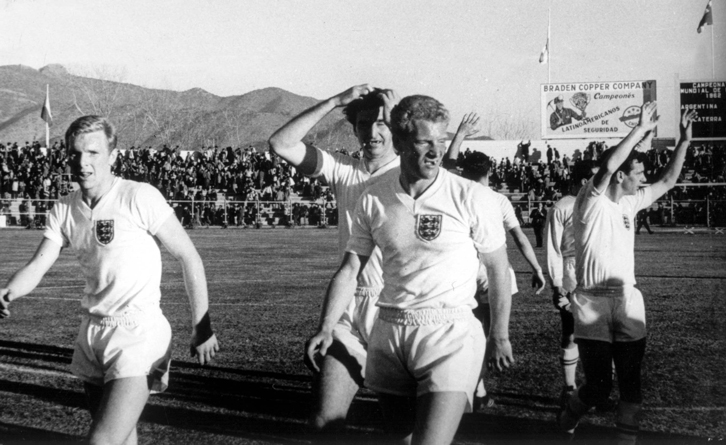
[{"xmin": 307, "ymin": 96, "xmax": 513, "ymax": 443}]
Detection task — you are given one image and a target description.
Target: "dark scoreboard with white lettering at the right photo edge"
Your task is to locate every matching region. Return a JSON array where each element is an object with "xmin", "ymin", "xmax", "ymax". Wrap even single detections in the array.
[{"xmin": 679, "ymin": 81, "xmax": 726, "ymax": 141}]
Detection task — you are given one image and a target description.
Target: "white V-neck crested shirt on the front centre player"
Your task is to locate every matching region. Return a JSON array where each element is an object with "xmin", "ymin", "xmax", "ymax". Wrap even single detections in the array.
[{"xmin": 347, "ymin": 169, "xmax": 506, "ymax": 309}]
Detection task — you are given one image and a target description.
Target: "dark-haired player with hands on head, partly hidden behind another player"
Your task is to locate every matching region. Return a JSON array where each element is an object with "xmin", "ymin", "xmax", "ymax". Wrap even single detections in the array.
[{"xmin": 269, "ymin": 84, "xmax": 399, "ymax": 430}]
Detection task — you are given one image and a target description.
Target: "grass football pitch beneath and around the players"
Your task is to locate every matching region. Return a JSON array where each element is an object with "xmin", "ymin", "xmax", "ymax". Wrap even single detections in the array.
[{"xmin": 0, "ymin": 228, "xmax": 726, "ymax": 445}]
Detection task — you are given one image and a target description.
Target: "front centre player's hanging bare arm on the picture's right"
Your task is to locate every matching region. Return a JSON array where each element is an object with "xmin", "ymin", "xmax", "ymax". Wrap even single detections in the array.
[{"xmin": 481, "ymin": 245, "xmax": 514, "ymax": 372}]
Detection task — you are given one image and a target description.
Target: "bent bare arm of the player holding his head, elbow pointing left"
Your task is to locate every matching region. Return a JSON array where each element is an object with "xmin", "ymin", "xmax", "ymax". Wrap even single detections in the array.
[{"xmin": 268, "ymin": 84, "xmax": 372, "ymax": 175}]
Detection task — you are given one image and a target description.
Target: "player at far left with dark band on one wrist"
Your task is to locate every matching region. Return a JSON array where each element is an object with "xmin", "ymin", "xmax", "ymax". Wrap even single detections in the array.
[{"xmin": 0, "ymin": 116, "xmax": 219, "ymax": 444}]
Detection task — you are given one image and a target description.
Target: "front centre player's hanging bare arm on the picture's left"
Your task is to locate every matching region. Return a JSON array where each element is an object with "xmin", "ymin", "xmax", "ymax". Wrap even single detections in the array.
[{"xmin": 305, "ymin": 252, "xmax": 368, "ymax": 372}]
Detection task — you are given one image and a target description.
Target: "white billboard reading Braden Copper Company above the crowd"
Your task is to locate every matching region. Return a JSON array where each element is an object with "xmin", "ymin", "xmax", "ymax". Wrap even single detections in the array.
[{"xmin": 540, "ymin": 80, "xmax": 656, "ymax": 139}]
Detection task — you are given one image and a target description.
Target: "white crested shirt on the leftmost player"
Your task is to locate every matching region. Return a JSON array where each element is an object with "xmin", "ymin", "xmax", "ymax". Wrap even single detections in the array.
[{"xmin": 43, "ymin": 178, "xmax": 174, "ymax": 317}]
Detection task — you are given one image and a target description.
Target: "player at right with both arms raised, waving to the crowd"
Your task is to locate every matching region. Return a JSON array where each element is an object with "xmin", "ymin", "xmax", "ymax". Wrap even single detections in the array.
[{"xmin": 558, "ymin": 102, "xmax": 697, "ymax": 444}]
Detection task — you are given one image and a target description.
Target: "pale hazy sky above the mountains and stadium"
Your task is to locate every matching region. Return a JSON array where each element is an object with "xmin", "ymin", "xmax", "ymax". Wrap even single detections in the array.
[{"xmin": 0, "ymin": 0, "xmax": 726, "ymax": 137}]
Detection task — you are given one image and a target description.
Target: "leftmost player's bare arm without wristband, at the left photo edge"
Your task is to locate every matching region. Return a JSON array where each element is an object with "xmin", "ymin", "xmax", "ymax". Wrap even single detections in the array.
[{"xmin": 0, "ymin": 238, "xmax": 62, "ymax": 318}]
